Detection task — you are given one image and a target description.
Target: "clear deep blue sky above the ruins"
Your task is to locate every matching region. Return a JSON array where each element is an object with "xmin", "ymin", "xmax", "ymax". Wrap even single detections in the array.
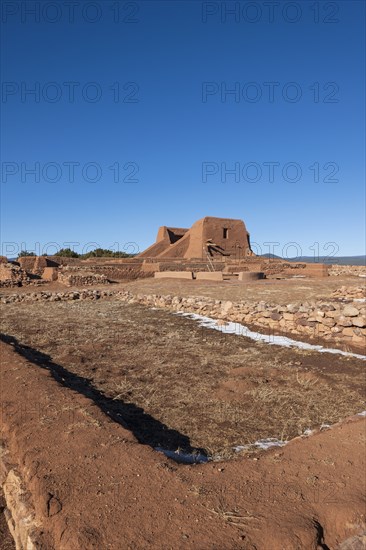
[{"xmin": 1, "ymin": 0, "xmax": 365, "ymax": 256}]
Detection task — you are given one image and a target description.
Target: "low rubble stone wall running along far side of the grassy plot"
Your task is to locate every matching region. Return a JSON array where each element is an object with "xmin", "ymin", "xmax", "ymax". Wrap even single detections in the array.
[{"xmin": 1, "ymin": 289, "xmax": 366, "ymax": 347}]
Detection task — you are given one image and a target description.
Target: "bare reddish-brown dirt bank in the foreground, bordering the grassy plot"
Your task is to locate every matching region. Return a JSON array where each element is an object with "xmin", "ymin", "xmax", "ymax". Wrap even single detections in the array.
[{"xmin": 0, "ymin": 343, "xmax": 366, "ymax": 550}]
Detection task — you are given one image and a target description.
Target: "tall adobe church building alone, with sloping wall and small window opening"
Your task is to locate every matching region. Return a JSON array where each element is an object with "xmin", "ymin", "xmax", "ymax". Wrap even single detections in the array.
[{"xmin": 138, "ymin": 217, "xmax": 253, "ymax": 260}]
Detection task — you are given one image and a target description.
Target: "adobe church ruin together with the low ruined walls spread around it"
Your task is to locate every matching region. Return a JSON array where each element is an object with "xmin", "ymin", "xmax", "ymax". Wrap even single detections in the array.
[{"xmin": 0, "ymin": 216, "xmax": 332, "ymax": 288}]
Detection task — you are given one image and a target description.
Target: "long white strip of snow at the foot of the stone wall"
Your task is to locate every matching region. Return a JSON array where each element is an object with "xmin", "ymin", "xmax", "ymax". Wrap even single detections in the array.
[{"xmin": 175, "ymin": 311, "xmax": 366, "ymax": 360}]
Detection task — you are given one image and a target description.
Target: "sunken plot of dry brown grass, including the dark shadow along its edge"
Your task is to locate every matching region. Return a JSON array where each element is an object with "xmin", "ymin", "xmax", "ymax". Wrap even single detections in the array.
[{"xmin": 1, "ymin": 299, "xmax": 366, "ymax": 458}]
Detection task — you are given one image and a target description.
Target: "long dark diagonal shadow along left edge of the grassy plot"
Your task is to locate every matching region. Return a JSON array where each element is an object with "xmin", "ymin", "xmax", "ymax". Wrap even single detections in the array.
[{"xmin": 0, "ymin": 334, "xmax": 207, "ymax": 456}]
